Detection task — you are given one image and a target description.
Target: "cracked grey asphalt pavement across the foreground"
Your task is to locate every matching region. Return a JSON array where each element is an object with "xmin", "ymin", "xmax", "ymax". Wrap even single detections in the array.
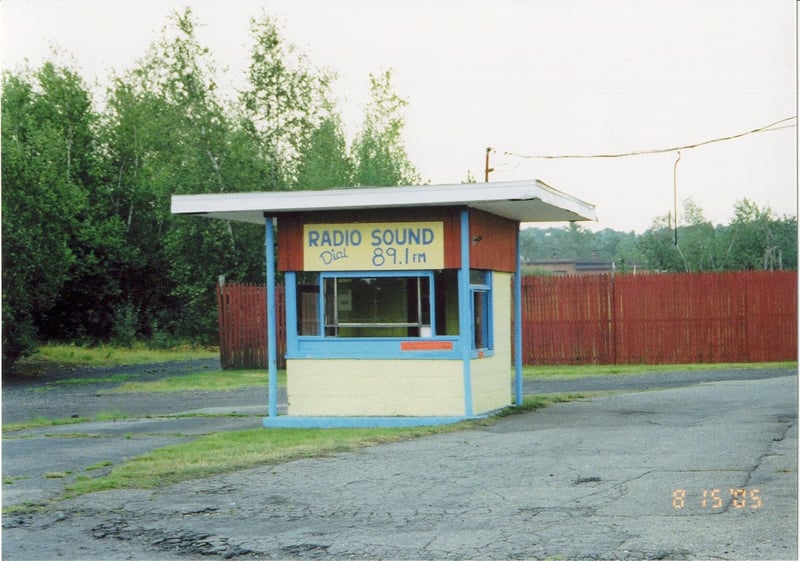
[{"xmin": 2, "ymin": 369, "xmax": 798, "ymax": 561}]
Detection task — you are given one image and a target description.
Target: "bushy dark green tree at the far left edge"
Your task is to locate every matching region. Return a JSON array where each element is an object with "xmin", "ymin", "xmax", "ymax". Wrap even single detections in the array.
[{"xmin": 2, "ymin": 63, "xmax": 109, "ymax": 365}]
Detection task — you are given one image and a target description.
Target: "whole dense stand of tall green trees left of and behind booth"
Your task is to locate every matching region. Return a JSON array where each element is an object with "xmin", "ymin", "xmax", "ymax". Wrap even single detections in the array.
[{"xmin": 2, "ymin": 9, "xmax": 351, "ymax": 365}]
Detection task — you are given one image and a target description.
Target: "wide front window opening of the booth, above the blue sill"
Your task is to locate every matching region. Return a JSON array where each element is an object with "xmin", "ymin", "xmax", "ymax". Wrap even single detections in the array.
[{"xmin": 297, "ymin": 271, "xmax": 458, "ymax": 338}]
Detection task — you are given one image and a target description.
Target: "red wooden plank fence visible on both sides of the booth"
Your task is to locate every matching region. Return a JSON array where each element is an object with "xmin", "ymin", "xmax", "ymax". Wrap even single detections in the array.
[{"xmin": 217, "ymin": 271, "xmax": 797, "ymax": 368}]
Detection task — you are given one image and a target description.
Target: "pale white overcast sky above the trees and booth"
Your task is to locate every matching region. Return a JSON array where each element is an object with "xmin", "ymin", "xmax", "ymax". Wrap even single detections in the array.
[{"xmin": 0, "ymin": 0, "xmax": 798, "ymax": 232}]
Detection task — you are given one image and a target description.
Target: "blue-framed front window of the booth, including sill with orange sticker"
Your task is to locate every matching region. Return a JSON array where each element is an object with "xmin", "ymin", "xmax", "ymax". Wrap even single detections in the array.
[{"xmin": 286, "ymin": 269, "xmax": 476, "ymax": 360}]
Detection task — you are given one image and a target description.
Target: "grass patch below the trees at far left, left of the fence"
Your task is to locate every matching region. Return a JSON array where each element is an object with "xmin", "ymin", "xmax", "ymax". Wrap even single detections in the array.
[{"xmin": 14, "ymin": 344, "xmax": 219, "ymax": 376}]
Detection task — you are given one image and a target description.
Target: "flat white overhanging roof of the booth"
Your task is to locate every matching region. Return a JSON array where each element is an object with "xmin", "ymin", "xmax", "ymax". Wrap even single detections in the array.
[{"xmin": 171, "ymin": 179, "xmax": 597, "ymax": 224}]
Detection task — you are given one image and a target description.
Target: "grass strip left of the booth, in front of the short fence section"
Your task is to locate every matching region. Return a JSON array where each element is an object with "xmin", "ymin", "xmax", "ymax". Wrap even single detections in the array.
[{"xmin": 113, "ymin": 370, "xmax": 276, "ymax": 393}]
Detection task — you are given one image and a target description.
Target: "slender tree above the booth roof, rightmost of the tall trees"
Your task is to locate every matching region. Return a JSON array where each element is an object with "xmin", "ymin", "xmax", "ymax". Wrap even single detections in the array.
[{"xmin": 353, "ymin": 70, "xmax": 420, "ymax": 187}]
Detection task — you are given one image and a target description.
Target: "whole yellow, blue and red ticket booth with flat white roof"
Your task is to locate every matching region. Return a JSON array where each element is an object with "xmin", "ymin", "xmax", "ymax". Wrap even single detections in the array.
[{"xmin": 172, "ymin": 180, "xmax": 595, "ymax": 427}]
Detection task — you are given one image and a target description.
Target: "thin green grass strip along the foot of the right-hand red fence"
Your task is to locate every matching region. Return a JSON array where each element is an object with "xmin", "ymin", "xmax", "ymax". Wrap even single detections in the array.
[{"xmin": 522, "ymin": 362, "xmax": 797, "ymax": 380}]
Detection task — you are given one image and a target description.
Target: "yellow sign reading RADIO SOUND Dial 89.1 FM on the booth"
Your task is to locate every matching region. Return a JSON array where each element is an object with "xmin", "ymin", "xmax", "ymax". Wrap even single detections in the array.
[{"xmin": 303, "ymin": 222, "xmax": 444, "ymax": 271}]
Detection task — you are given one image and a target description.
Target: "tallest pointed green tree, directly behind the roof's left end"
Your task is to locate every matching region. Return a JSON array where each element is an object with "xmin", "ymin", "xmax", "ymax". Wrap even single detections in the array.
[{"xmin": 101, "ymin": 9, "xmax": 264, "ymax": 338}]
